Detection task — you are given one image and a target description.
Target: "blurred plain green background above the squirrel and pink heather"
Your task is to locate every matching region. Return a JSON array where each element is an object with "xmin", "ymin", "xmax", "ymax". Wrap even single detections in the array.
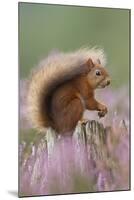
[{"xmin": 19, "ymin": 3, "xmax": 129, "ymax": 88}]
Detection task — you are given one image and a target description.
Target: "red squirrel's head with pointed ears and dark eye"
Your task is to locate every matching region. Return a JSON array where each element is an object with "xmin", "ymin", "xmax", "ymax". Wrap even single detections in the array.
[{"xmin": 86, "ymin": 58, "xmax": 111, "ymax": 89}]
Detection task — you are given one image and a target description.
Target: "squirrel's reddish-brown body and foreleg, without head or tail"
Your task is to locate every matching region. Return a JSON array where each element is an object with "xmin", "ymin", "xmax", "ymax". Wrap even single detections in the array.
[{"xmin": 51, "ymin": 72, "xmax": 106, "ymax": 134}]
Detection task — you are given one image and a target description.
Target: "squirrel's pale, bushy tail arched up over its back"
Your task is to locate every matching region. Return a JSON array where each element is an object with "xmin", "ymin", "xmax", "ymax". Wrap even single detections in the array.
[{"xmin": 27, "ymin": 48, "xmax": 105, "ymax": 131}]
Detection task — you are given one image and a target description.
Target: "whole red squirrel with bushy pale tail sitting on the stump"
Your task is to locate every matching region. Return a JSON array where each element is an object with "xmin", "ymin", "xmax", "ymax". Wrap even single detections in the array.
[{"xmin": 27, "ymin": 48, "xmax": 110, "ymax": 135}]
